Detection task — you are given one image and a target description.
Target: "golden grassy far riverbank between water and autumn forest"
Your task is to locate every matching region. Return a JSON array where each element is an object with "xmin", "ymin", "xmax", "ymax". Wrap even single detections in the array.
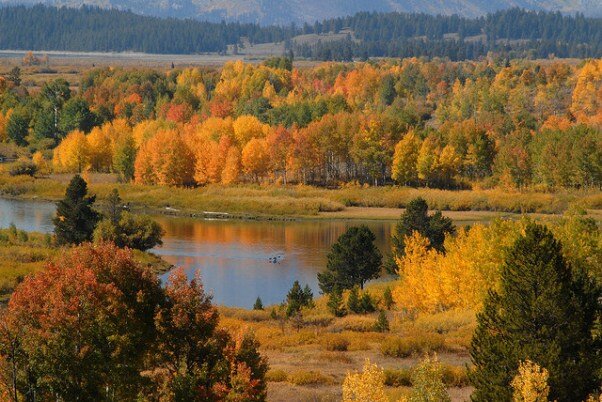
[{"xmin": 0, "ymin": 174, "xmax": 602, "ymax": 222}]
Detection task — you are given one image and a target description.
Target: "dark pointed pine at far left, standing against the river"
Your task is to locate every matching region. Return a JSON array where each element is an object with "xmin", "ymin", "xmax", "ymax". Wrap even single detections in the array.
[{"xmin": 53, "ymin": 175, "xmax": 100, "ymax": 245}]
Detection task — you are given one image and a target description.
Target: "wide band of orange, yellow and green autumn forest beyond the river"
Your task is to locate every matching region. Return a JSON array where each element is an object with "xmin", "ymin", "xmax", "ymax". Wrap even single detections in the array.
[{"xmin": 0, "ymin": 58, "xmax": 602, "ymax": 192}]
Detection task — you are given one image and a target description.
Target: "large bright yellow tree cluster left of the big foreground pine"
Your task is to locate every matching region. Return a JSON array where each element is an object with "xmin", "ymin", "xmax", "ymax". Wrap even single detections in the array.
[{"xmin": 393, "ymin": 220, "xmax": 525, "ymax": 313}]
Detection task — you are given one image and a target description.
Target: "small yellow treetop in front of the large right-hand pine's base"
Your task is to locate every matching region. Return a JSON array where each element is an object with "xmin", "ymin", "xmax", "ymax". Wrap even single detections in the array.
[{"xmin": 512, "ymin": 360, "xmax": 550, "ymax": 402}]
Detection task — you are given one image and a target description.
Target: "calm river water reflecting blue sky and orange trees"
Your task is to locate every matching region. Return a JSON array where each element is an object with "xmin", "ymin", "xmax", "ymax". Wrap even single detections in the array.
[{"xmin": 0, "ymin": 199, "xmax": 394, "ymax": 307}]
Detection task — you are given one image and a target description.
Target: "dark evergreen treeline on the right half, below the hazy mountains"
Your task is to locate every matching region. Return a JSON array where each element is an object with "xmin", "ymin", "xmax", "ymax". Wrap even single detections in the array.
[{"xmin": 295, "ymin": 8, "xmax": 602, "ymax": 60}]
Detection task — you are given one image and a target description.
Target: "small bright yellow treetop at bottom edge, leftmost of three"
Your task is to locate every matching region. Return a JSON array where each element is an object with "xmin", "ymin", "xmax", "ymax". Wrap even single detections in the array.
[{"xmin": 343, "ymin": 359, "xmax": 388, "ymax": 402}]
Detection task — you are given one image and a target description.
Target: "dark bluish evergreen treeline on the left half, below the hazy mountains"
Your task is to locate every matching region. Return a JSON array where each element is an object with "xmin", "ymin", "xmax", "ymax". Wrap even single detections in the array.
[{"xmin": 0, "ymin": 5, "xmax": 297, "ymax": 54}]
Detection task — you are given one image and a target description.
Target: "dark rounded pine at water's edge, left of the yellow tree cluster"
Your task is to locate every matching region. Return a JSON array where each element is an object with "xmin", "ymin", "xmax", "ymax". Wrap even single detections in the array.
[{"xmin": 318, "ymin": 226, "xmax": 382, "ymax": 293}]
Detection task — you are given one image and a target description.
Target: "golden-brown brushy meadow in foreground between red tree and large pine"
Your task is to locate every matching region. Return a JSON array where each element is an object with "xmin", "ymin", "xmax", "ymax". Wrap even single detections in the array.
[{"xmin": 220, "ymin": 282, "xmax": 476, "ymax": 401}]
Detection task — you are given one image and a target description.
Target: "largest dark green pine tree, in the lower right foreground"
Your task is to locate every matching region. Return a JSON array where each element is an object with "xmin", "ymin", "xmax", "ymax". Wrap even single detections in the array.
[{"xmin": 470, "ymin": 224, "xmax": 602, "ymax": 402}]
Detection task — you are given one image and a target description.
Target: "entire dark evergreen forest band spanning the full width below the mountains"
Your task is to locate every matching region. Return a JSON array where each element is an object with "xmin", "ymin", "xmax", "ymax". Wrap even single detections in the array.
[{"xmin": 0, "ymin": 5, "xmax": 602, "ymax": 60}]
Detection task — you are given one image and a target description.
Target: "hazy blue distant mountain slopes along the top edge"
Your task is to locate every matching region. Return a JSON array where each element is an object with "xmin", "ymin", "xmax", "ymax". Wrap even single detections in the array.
[{"xmin": 0, "ymin": 0, "xmax": 602, "ymax": 25}]
